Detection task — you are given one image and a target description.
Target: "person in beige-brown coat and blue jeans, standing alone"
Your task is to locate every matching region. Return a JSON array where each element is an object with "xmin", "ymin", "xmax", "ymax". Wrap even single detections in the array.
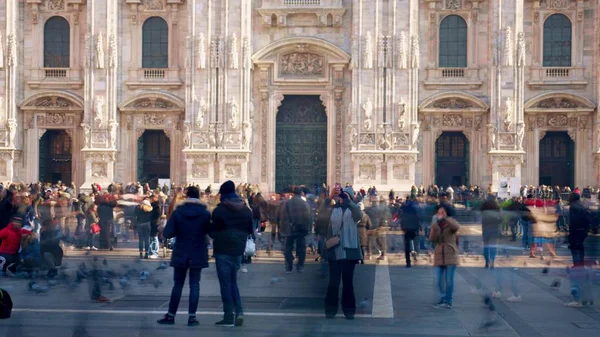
[{"xmin": 429, "ymin": 204, "xmax": 460, "ymax": 309}]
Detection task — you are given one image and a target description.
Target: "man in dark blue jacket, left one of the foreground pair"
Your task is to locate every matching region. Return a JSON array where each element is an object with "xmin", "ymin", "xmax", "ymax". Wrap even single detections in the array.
[{"xmin": 158, "ymin": 186, "xmax": 210, "ymax": 326}]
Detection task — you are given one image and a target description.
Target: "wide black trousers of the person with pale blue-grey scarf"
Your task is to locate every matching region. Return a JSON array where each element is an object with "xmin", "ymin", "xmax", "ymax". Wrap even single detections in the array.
[{"xmin": 325, "ymin": 260, "xmax": 356, "ymax": 316}]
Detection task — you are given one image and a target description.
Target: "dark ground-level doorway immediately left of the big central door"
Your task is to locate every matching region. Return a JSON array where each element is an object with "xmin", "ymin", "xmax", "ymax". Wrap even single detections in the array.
[{"xmin": 137, "ymin": 130, "xmax": 171, "ymax": 188}]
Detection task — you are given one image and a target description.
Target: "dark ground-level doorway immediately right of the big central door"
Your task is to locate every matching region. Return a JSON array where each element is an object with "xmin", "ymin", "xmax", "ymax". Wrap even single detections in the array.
[{"xmin": 435, "ymin": 131, "xmax": 469, "ymax": 188}]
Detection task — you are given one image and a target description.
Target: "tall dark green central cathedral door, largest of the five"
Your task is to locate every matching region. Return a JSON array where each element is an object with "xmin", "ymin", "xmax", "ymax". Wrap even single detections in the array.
[{"xmin": 275, "ymin": 95, "xmax": 327, "ymax": 192}]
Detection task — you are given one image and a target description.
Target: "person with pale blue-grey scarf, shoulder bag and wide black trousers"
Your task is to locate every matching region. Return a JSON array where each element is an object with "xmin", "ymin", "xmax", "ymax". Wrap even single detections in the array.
[{"xmin": 325, "ymin": 187, "xmax": 363, "ymax": 319}]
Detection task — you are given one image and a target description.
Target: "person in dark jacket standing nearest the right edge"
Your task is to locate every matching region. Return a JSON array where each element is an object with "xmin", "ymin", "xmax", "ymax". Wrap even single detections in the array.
[{"xmin": 569, "ymin": 193, "xmax": 592, "ymax": 267}]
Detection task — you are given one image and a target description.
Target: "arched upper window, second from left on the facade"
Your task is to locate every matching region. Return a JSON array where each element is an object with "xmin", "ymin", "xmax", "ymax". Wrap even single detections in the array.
[{"xmin": 142, "ymin": 16, "xmax": 169, "ymax": 68}]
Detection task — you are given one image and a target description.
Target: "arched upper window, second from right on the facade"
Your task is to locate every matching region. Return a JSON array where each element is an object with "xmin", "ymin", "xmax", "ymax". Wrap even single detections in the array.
[{"xmin": 439, "ymin": 15, "xmax": 467, "ymax": 68}]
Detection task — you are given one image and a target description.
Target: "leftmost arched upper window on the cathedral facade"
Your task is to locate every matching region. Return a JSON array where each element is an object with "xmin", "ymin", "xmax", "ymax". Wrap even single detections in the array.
[{"xmin": 44, "ymin": 16, "xmax": 71, "ymax": 68}]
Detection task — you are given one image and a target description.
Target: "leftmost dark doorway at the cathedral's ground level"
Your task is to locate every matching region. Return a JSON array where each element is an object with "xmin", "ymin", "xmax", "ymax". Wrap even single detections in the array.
[{"xmin": 39, "ymin": 130, "xmax": 73, "ymax": 184}]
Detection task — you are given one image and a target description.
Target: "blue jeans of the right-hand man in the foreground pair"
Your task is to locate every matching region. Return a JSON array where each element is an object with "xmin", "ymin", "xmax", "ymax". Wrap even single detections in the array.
[{"xmin": 215, "ymin": 254, "xmax": 244, "ymax": 321}]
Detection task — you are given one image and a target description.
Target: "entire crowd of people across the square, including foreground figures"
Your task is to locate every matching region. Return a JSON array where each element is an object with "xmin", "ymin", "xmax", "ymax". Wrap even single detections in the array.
[{"xmin": 0, "ymin": 181, "xmax": 596, "ymax": 326}]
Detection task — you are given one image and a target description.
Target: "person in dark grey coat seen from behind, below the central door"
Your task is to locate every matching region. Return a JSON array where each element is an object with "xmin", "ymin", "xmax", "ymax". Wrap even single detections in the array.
[{"xmin": 279, "ymin": 187, "xmax": 312, "ymax": 274}]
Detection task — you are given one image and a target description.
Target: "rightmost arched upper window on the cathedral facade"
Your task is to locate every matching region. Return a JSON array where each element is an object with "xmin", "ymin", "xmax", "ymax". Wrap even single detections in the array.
[{"xmin": 544, "ymin": 14, "xmax": 572, "ymax": 67}]
